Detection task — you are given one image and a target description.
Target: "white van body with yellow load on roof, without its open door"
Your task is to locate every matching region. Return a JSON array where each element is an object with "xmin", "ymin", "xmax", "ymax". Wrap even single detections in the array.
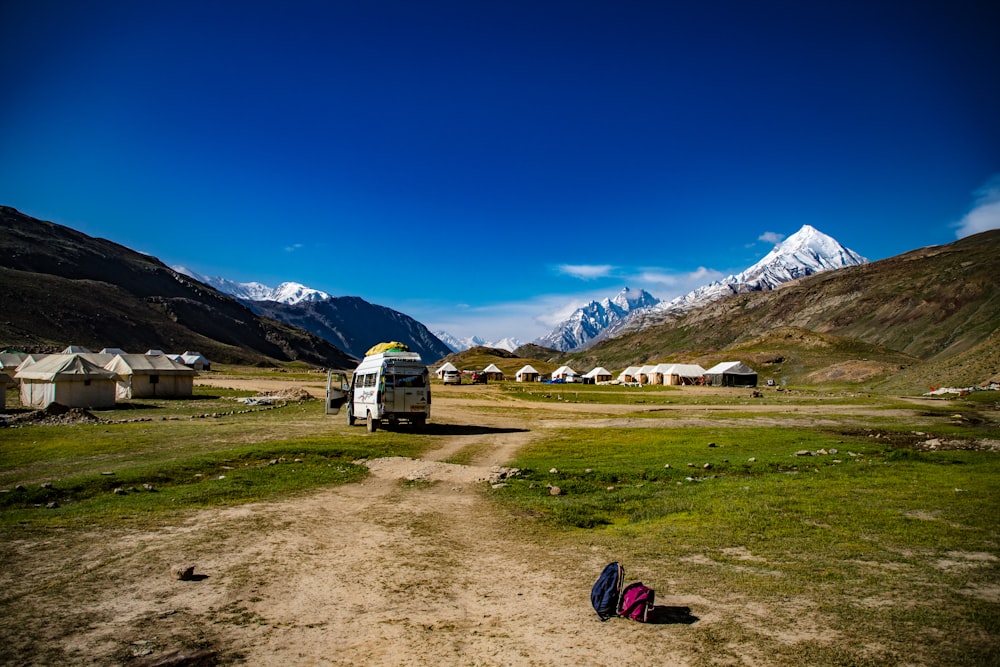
[{"xmin": 347, "ymin": 351, "xmax": 431, "ymax": 432}]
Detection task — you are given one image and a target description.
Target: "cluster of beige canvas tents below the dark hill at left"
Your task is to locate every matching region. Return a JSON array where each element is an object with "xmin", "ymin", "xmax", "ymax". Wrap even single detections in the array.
[{"xmin": 0, "ymin": 347, "xmax": 211, "ymax": 409}]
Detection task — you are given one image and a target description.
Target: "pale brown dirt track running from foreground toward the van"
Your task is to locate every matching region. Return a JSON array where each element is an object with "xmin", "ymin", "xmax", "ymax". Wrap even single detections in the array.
[{"xmin": 0, "ymin": 400, "xmax": 708, "ymax": 667}]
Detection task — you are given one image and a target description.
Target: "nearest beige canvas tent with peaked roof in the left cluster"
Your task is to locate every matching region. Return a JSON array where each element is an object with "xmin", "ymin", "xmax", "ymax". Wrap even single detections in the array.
[{"xmin": 14, "ymin": 354, "xmax": 118, "ymax": 408}]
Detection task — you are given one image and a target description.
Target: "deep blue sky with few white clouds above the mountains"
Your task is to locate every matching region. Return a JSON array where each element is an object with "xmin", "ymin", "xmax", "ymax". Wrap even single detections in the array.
[{"xmin": 0, "ymin": 0, "xmax": 1000, "ymax": 340}]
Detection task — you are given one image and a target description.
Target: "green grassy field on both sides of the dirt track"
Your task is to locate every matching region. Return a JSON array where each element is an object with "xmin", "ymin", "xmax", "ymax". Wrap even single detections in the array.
[{"xmin": 0, "ymin": 374, "xmax": 1000, "ymax": 665}]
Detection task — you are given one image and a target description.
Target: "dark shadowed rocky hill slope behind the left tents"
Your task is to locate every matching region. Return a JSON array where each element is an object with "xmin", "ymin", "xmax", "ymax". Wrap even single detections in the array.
[{"xmin": 0, "ymin": 206, "xmax": 354, "ymax": 368}]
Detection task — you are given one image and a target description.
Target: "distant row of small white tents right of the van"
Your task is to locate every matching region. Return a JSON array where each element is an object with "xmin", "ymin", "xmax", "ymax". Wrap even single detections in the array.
[{"xmin": 435, "ymin": 361, "xmax": 757, "ymax": 387}]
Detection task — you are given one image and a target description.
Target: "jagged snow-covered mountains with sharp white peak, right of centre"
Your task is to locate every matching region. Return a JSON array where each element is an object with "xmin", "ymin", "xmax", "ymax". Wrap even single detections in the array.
[{"xmin": 537, "ymin": 225, "xmax": 868, "ymax": 352}]
